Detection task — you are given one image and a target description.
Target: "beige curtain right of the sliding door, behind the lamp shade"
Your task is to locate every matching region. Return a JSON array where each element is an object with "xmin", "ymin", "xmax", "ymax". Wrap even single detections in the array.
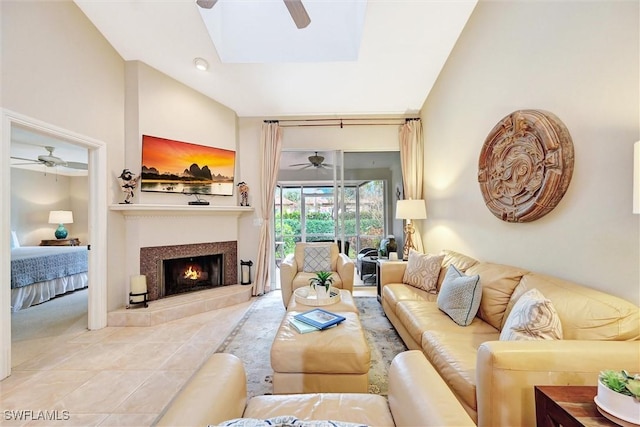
[{"xmin": 400, "ymin": 119, "xmax": 424, "ymax": 252}]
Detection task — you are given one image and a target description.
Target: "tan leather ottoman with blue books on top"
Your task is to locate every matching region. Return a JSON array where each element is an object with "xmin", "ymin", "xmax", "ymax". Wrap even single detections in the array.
[{"xmin": 271, "ymin": 306, "xmax": 371, "ymax": 394}]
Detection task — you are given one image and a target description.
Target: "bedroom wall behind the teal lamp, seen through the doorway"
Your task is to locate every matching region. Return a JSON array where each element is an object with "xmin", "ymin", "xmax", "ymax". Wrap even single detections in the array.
[{"xmin": 11, "ymin": 168, "xmax": 88, "ymax": 246}]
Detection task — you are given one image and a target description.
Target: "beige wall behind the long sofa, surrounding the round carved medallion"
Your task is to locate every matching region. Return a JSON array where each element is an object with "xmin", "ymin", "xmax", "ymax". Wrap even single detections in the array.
[{"xmin": 422, "ymin": 1, "xmax": 640, "ymax": 303}]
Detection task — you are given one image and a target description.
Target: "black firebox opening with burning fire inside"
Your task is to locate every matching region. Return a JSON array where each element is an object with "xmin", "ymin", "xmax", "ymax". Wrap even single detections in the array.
[{"xmin": 160, "ymin": 254, "xmax": 224, "ymax": 297}]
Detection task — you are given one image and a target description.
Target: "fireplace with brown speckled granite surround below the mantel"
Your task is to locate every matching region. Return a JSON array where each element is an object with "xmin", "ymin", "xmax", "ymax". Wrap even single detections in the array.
[{"xmin": 140, "ymin": 241, "xmax": 238, "ymax": 301}]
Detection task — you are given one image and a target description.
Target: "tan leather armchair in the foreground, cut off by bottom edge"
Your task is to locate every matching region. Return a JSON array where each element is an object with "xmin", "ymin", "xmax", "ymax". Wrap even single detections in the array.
[{"xmin": 156, "ymin": 351, "xmax": 474, "ymax": 427}]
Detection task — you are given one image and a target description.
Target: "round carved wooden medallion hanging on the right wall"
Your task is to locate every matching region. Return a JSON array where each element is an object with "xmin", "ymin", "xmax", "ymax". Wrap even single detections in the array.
[{"xmin": 478, "ymin": 110, "xmax": 574, "ymax": 222}]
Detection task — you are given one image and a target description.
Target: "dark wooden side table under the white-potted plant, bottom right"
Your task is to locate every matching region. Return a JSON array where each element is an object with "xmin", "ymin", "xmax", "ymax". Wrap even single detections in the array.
[{"xmin": 534, "ymin": 386, "xmax": 618, "ymax": 427}]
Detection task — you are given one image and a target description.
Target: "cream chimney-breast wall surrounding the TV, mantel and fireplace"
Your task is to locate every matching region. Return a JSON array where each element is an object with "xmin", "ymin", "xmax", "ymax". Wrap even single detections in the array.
[{"xmin": 117, "ymin": 61, "xmax": 240, "ymax": 305}]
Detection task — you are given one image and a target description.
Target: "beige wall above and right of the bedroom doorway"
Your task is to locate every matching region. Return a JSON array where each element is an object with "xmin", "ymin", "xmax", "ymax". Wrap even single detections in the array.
[{"xmin": 0, "ymin": 1, "xmax": 125, "ymax": 314}]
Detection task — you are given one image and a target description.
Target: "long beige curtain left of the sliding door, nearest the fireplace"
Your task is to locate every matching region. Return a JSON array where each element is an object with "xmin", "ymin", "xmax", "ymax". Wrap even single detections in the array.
[{"xmin": 253, "ymin": 122, "xmax": 282, "ymax": 295}]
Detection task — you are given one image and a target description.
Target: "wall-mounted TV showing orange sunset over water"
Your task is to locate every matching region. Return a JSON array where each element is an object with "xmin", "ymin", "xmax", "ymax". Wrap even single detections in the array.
[{"xmin": 140, "ymin": 135, "xmax": 236, "ymax": 196}]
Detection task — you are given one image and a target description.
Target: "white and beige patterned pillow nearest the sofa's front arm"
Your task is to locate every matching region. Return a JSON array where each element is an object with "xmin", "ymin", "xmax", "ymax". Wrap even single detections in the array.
[{"xmin": 500, "ymin": 289, "xmax": 562, "ymax": 341}]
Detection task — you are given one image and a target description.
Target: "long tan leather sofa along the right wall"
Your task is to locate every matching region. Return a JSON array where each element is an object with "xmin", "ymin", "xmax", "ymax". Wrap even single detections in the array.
[{"xmin": 380, "ymin": 251, "xmax": 640, "ymax": 426}]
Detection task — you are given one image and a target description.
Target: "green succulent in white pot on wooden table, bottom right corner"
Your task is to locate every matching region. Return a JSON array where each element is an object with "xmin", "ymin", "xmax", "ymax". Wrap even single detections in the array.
[{"xmin": 596, "ymin": 369, "xmax": 640, "ymax": 424}]
